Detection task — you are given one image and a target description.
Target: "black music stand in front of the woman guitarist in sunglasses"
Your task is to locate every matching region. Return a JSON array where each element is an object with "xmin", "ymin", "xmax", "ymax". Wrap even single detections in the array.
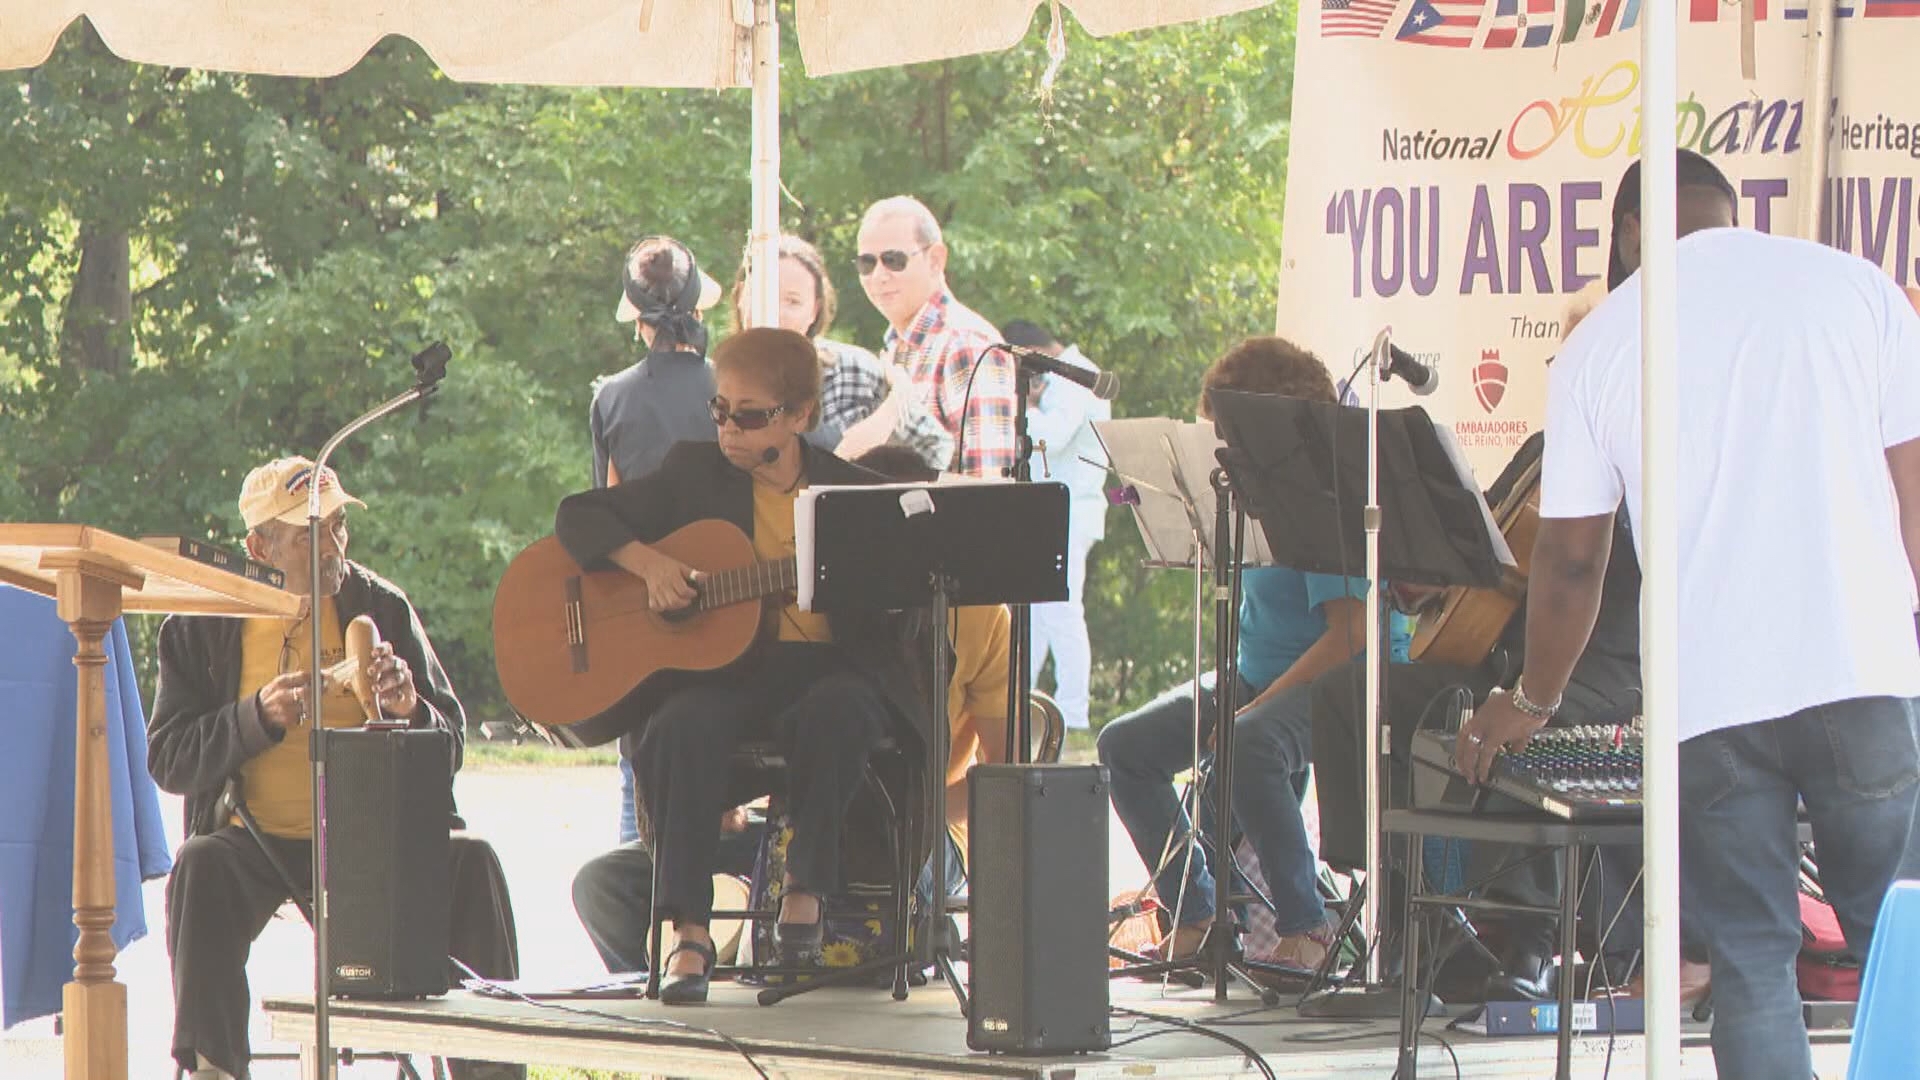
[{"xmin": 779, "ymin": 482, "xmax": 1068, "ymax": 1017}]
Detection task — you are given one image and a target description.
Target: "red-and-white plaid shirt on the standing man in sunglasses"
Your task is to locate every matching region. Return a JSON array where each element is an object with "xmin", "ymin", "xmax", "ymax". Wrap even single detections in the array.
[{"xmin": 885, "ymin": 288, "xmax": 1014, "ymax": 477}]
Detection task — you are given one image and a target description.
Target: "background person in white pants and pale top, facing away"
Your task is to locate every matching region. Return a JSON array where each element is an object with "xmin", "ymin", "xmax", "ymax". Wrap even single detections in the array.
[{"xmin": 1000, "ymin": 319, "xmax": 1114, "ymax": 730}]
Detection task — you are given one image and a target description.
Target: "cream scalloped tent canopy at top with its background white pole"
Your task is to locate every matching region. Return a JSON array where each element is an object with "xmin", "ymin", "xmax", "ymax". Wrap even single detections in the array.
[{"xmin": 0, "ymin": 0, "xmax": 1271, "ymax": 325}]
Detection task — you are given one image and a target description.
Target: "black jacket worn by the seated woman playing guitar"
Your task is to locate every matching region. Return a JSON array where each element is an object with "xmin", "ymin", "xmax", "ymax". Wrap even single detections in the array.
[{"xmin": 553, "ymin": 440, "xmax": 931, "ymax": 746}]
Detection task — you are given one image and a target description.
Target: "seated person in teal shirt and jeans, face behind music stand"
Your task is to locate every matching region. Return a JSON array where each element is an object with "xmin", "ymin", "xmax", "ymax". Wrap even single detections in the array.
[{"xmin": 1098, "ymin": 336, "xmax": 1409, "ymax": 970}]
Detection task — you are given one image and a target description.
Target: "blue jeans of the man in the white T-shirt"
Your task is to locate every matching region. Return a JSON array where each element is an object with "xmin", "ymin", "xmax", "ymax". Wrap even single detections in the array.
[{"xmin": 1680, "ymin": 698, "xmax": 1920, "ymax": 1080}]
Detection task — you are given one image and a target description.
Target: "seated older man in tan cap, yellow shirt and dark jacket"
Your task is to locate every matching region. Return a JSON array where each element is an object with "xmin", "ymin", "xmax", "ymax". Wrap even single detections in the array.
[{"xmin": 148, "ymin": 457, "xmax": 524, "ymax": 1080}]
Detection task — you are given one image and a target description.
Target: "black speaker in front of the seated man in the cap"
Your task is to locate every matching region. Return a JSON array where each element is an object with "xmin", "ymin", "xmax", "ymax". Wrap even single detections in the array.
[{"xmin": 326, "ymin": 728, "xmax": 453, "ymax": 999}]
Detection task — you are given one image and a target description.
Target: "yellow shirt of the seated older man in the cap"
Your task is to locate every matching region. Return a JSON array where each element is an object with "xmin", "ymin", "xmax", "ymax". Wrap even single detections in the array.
[{"xmin": 240, "ymin": 596, "xmax": 367, "ymax": 840}]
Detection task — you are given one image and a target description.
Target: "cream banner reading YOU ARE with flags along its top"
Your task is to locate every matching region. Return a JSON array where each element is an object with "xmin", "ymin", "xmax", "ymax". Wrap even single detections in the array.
[{"xmin": 1277, "ymin": 0, "xmax": 1920, "ymax": 480}]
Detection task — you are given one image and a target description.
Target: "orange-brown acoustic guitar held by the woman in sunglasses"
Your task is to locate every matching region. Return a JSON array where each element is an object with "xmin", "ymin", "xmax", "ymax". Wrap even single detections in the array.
[{"xmin": 493, "ymin": 521, "xmax": 799, "ymax": 734}]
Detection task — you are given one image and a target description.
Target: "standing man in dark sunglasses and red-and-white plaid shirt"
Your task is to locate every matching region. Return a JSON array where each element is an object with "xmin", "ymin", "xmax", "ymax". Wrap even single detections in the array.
[{"xmin": 854, "ymin": 196, "xmax": 1014, "ymax": 477}]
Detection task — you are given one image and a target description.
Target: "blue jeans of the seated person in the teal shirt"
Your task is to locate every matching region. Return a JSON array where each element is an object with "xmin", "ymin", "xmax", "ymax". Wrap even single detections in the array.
[{"xmin": 1098, "ymin": 676, "xmax": 1327, "ymax": 934}]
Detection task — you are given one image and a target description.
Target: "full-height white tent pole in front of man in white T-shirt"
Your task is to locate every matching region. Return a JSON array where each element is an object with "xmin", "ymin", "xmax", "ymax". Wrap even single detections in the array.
[{"xmin": 1635, "ymin": 0, "xmax": 1680, "ymax": 1080}]
